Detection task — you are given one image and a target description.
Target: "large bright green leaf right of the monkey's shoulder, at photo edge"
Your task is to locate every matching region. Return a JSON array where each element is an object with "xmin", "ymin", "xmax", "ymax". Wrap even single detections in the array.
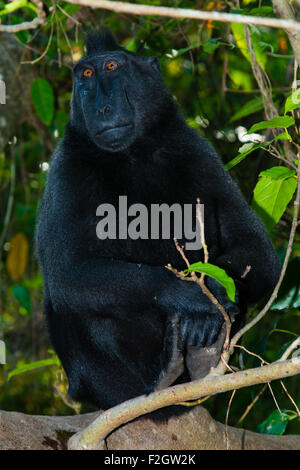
[{"xmin": 252, "ymin": 167, "xmax": 297, "ymax": 232}]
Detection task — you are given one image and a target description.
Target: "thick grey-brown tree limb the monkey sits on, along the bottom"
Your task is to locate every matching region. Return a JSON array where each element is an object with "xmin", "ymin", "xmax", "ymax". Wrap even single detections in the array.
[{"xmin": 0, "ymin": 406, "xmax": 300, "ymax": 450}]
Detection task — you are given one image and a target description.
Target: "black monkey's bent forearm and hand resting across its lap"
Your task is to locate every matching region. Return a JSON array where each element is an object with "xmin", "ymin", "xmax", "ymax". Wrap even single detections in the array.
[{"xmin": 36, "ymin": 202, "xmax": 235, "ymax": 344}]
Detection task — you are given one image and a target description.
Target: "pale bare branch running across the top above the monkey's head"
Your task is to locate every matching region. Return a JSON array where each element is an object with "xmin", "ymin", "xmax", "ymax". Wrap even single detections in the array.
[{"xmin": 65, "ymin": 0, "xmax": 300, "ymax": 34}]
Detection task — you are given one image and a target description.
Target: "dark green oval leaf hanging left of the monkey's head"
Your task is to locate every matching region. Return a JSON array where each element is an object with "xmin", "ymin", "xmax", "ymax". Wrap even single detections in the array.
[{"xmin": 31, "ymin": 78, "xmax": 54, "ymax": 126}]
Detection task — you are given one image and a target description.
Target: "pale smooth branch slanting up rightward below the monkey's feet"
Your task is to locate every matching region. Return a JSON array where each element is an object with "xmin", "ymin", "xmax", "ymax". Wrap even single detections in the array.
[{"xmin": 68, "ymin": 357, "xmax": 300, "ymax": 450}]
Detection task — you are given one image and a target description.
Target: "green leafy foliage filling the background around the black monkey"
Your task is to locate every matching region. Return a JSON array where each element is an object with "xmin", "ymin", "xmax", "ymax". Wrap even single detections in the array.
[{"xmin": 0, "ymin": 0, "xmax": 300, "ymax": 434}]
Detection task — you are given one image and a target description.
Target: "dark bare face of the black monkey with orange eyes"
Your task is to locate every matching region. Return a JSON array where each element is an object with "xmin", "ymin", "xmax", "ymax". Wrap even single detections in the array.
[{"xmin": 72, "ymin": 51, "xmax": 169, "ymax": 152}]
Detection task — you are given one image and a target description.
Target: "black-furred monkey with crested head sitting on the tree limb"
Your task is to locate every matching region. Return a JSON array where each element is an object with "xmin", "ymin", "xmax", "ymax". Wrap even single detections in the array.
[{"xmin": 36, "ymin": 36, "xmax": 280, "ymax": 408}]
